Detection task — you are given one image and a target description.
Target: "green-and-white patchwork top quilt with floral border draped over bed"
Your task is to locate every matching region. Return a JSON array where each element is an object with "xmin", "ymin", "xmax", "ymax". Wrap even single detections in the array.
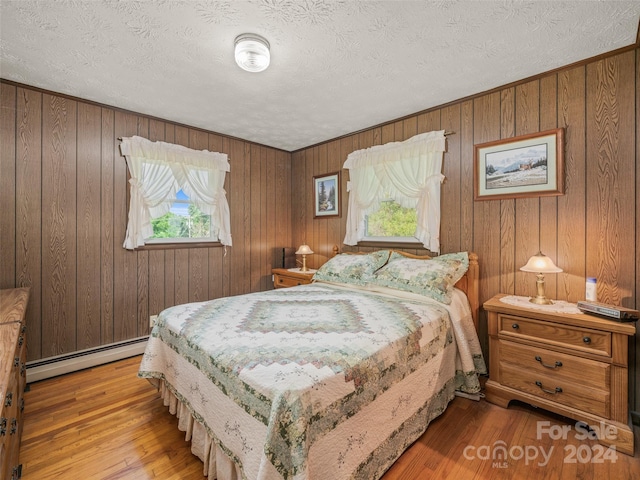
[{"xmin": 139, "ymin": 283, "xmax": 482, "ymax": 478}]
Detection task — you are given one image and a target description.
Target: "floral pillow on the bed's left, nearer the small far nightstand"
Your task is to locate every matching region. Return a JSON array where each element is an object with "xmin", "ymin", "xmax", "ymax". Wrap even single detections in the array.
[{"xmin": 313, "ymin": 250, "xmax": 390, "ymax": 285}]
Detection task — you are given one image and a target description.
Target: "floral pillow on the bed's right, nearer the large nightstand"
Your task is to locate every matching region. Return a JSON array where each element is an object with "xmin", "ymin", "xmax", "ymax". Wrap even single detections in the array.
[{"xmin": 372, "ymin": 252, "xmax": 469, "ymax": 304}]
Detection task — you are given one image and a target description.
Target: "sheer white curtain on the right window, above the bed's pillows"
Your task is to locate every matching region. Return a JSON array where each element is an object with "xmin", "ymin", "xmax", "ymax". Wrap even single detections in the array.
[{"xmin": 344, "ymin": 130, "xmax": 446, "ymax": 253}]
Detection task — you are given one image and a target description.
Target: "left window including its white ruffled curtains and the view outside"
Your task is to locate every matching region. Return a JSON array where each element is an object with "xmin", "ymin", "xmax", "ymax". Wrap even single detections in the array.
[{"xmin": 120, "ymin": 137, "xmax": 231, "ymax": 250}]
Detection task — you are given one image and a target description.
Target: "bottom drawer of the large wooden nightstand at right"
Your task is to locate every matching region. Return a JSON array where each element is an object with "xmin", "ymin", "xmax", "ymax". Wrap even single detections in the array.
[{"xmin": 500, "ymin": 363, "xmax": 610, "ymax": 418}]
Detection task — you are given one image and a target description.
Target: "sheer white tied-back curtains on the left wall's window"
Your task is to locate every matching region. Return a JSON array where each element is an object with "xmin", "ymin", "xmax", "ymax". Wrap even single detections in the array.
[{"xmin": 120, "ymin": 136, "xmax": 231, "ymax": 250}]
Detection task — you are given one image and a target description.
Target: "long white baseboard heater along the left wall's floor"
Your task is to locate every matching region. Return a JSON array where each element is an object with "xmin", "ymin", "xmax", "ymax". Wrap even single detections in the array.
[{"xmin": 27, "ymin": 336, "xmax": 149, "ymax": 383}]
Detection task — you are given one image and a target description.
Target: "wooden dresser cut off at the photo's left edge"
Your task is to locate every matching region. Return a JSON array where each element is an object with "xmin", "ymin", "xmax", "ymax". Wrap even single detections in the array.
[{"xmin": 0, "ymin": 288, "xmax": 29, "ymax": 480}]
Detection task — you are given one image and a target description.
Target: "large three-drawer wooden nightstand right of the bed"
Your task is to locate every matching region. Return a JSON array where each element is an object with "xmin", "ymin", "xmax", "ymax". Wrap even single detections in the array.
[{"xmin": 484, "ymin": 295, "xmax": 635, "ymax": 455}]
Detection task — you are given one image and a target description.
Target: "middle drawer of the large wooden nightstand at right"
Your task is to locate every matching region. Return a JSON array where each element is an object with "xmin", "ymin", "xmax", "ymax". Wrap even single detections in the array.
[{"xmin": 498, "ymin": 340, "xmax": 611, "ymax": 390}]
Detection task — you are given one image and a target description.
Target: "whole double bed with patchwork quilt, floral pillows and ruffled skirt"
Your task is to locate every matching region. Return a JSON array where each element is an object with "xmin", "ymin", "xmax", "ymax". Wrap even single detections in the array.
[{"xmin": 138, "ymin": 250, "xmax": 486, "ymax": 480}]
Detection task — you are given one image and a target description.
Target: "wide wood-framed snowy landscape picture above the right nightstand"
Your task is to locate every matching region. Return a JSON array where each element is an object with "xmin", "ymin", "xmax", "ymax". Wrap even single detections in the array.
[{"xmin": 473, "ymin": 128, "xmax": 564, "ymax": 200}]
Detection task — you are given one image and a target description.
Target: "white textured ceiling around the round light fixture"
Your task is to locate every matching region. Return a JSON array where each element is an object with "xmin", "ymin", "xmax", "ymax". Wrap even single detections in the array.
[{"xmin": 0, "ymin": 0, "xmax": 640, "ymax": 151}]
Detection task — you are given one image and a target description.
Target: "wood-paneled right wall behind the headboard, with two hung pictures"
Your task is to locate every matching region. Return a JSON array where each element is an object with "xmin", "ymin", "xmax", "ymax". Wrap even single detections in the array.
[{"xmin": 292, "ymin": 49, "xmax": 640, "ymax": 411}]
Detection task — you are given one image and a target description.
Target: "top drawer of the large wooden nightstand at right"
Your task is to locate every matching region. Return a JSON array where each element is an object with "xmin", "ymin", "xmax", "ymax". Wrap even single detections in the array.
[{"xmin": 498, "ymin": 314, "xmax": 611, "ymax": 357}]
